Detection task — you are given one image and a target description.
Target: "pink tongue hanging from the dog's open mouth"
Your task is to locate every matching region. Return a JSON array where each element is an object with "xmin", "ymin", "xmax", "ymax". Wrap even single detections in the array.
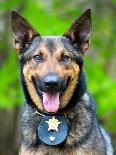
[{"xmin": 43, "ymin": 92, "xmax": 60, "ymax": 112}]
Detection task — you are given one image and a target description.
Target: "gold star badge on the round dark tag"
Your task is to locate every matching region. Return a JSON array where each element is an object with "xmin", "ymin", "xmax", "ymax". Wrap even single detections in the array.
[{"xmin": 45, "ymin": 116, "xmax": 62, "ymax": 132}]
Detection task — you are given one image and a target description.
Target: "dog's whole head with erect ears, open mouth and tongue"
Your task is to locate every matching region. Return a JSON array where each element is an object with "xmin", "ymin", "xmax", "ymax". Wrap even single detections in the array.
[{"xmin": 11, "ymin": 9, "xmax": 91, "ymax": 112}]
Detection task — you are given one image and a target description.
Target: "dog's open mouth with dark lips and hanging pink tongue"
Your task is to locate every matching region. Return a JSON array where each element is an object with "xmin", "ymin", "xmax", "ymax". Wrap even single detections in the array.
[{"xmin": 32, "ymin": 77, "xmax": 69, "ymax": 113}]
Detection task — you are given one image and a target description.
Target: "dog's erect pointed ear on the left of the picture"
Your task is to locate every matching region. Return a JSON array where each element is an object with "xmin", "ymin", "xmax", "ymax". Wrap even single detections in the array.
[{"xmin": 11, "ymin": 11, "xmax": 40, "ymax": 55}]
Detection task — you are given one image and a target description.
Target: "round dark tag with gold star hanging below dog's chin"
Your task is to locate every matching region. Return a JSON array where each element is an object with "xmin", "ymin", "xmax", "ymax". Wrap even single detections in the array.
[{"xmin": 37, "ymin": 112, "xmax": 68, "ymax": 146}]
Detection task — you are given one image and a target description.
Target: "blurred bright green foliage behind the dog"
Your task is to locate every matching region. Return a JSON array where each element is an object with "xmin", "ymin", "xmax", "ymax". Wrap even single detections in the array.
[{"xmin": 0, "ymin": 0, "xmax": 116, "ymax": 135}]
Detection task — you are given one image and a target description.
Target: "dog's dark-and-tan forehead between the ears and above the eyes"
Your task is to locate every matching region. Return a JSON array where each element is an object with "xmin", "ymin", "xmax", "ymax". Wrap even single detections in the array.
[{"xmin": 23, "ymin": 36, "xmax": 79, "ymax": 57}]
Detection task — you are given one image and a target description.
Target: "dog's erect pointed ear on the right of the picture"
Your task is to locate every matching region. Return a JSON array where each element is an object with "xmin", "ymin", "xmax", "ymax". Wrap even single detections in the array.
[{"xmin": 64, "ymin": 9, "xmax": 92, "ymax": 54}]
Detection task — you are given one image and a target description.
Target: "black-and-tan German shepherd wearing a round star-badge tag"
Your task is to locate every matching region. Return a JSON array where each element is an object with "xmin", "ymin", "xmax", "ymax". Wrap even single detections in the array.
[{"xmin": 11, "ymin": 9, "xmax": 114, "ymax": 155}]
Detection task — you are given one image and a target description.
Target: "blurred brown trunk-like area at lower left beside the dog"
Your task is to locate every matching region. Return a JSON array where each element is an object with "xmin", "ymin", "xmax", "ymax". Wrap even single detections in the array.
[{"xmin": 0, "ymin": 107, "xmax": 20, "ymax": 155}]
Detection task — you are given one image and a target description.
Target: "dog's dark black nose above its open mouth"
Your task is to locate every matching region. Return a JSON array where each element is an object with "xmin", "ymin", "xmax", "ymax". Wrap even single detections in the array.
[{"xmin": 43, "ymin": 73, "xmax": 61, "ymax": 91}]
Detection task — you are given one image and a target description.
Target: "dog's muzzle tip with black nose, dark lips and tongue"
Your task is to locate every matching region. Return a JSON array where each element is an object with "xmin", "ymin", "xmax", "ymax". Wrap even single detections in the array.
[{"xmin": 36, "ymin": 72, "xmax": 66, "ymax": 113}]
